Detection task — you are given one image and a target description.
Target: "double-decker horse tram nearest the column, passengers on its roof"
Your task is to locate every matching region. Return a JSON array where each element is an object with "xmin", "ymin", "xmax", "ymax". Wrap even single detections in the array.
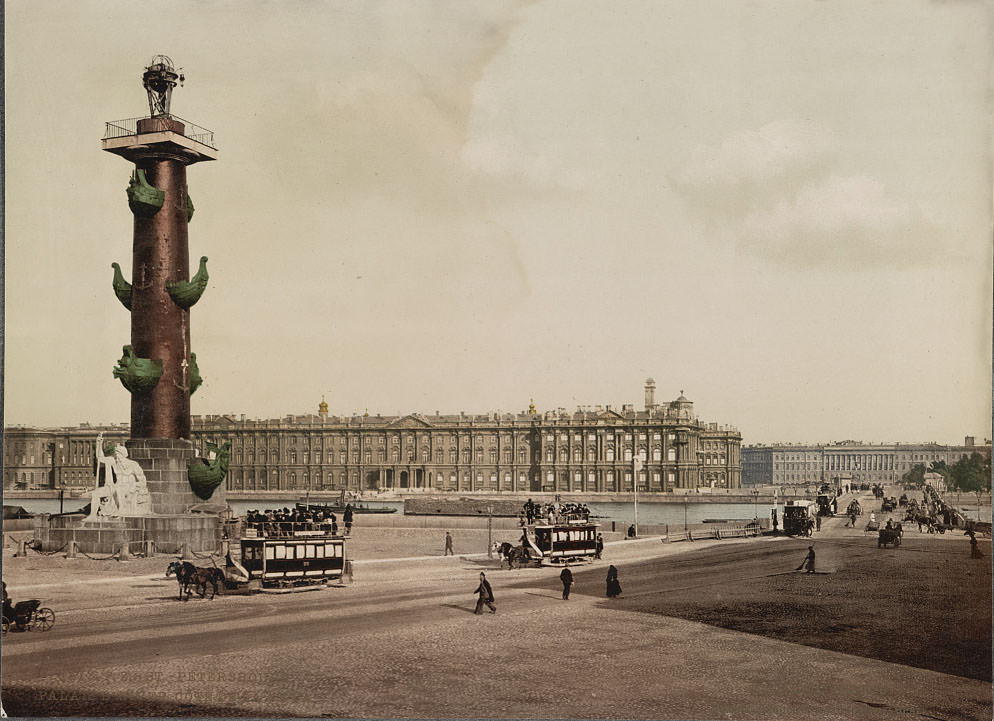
[{"xmin": 240, "ymin": 521, "xmax": 346, "ymax": 588}]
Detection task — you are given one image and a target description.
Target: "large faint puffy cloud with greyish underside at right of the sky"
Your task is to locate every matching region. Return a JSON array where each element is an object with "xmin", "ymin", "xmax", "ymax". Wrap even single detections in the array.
[{"xmin": 673, "ymin": 120, "xmax": 944, "ymax": 268}]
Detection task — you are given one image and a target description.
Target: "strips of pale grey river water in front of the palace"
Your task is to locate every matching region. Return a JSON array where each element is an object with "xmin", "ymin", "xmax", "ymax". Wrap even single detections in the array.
[{"xmin": 4, "ymin": 498, "xmax": 783, "ymax": 525}]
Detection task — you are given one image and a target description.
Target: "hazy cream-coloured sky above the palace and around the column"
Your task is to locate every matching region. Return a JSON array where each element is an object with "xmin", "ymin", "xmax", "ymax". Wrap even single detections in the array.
[{"xmin": 3, "ymin": 0, "xmax": 994, "ymax": 443}]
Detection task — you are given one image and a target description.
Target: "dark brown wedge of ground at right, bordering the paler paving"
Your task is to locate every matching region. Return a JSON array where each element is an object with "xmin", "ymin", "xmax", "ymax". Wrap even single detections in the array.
[{"xmin": 560, "ymin": 537, "xmax": 992, "ymax": 681}]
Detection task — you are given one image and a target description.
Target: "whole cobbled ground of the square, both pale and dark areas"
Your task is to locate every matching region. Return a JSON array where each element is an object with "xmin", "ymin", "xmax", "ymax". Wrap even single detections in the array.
[{"xmin": 3, "ymin": 490, "xmax": 991, "ymax": 721}]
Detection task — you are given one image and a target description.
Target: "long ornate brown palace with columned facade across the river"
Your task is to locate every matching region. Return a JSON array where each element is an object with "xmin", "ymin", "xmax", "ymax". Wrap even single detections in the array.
[{"xmin": 4, "ymin": 378, "xmax": 741, "ymax": 493}]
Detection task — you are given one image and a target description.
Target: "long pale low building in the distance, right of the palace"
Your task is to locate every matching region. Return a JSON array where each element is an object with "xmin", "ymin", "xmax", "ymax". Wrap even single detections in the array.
[{"xmin": 742, "ymin": 436, "xmax": 991, "ymax": 486}]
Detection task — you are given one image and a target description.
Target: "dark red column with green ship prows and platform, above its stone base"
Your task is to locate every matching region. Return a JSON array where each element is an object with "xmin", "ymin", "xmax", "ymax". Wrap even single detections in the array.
[{"xmin": 103, "ymin": 55, "xmax": 217, "ymax": 439}]
